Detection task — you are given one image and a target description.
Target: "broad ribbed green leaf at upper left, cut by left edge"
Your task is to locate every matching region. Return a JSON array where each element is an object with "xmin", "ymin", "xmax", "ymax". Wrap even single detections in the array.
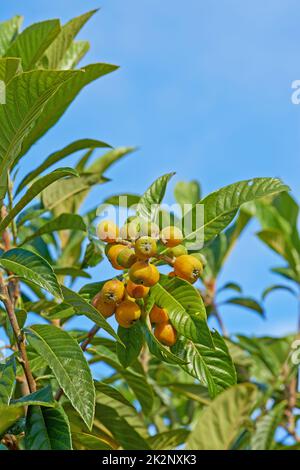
[{"xmin": 0, "ymin": 70, "xmax": 80, "ymax": 199}]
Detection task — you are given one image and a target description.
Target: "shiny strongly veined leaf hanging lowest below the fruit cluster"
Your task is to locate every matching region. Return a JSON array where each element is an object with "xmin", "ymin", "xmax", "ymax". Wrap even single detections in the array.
[{"xmin": 172, "ymin": 331, "xmax": 237, "ymax": 398}]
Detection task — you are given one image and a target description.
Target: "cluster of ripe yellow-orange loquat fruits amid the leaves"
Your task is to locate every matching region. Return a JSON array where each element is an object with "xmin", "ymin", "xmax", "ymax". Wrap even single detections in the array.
[{"xmin": 93, "ymin": 220, "xmax": 203, "ymax": 346}]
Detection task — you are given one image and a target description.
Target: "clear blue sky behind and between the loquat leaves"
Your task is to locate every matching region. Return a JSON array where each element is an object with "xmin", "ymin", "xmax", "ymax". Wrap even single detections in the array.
[{"xmin": 1, "ymin": 0, "xmax": 300, "ymax": 342}]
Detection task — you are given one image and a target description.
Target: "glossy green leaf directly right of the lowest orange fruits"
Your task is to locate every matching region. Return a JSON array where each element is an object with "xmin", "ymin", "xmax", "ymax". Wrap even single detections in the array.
[{"xmin": 151, "ymin": 275, "xmax": 213, "ymax": 347}]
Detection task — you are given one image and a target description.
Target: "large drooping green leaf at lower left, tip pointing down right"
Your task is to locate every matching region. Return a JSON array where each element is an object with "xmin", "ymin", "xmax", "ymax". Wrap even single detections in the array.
[{"xmin": 27, "ymin": 325, "xmax": 95, "ymax": 429}]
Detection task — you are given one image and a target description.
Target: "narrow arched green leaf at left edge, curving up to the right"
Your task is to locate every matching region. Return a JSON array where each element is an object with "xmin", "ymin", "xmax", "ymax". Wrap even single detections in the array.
[{"xmin": 0, "ymin": 168, "xmax": 77, "ymax": 232}]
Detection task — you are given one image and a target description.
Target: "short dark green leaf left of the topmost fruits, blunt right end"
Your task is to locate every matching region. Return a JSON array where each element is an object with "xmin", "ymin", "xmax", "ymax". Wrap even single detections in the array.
[{"xmin": 22, "ymin": 214, "xmax": 86, "ymax": 245}]
